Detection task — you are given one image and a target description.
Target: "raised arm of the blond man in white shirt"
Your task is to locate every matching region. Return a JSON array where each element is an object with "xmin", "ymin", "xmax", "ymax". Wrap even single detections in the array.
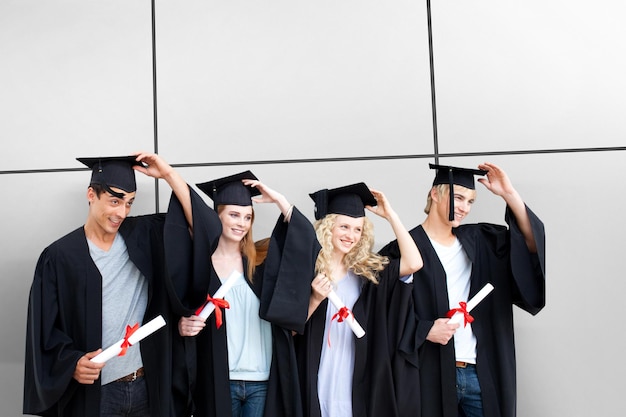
[{"xmin": 478, "ymin": 162, "xmax": 537, "ymax": 253}]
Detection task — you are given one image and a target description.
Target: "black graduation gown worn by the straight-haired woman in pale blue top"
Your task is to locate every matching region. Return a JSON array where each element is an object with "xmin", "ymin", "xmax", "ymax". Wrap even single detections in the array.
[{"xmin": 165, "ymin": 198, "xmax": 314, "ymax": 417}]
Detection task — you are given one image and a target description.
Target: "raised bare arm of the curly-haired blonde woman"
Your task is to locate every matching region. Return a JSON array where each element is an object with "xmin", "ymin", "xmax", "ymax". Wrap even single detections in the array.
[{"xmin": 366, "ymin": 190, "xmax": 424, "ymax": 276}]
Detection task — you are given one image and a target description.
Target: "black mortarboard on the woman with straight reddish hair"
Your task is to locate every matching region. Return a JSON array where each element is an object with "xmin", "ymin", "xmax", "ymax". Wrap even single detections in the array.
[{"xmin": 196, "ymin": 171, "xmax": 261, "ymax": 207}]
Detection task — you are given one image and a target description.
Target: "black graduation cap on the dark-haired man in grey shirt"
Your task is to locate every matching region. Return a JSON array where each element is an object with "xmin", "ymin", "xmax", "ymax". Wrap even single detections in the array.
[{"xmin": 76, "ymin": 155, "xmax": 142, "ymax": 198}]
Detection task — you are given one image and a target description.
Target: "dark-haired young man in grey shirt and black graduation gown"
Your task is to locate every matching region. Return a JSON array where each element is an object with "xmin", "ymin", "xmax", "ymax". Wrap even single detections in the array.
[{"xmin": 23, "ymin": 153, "xmax": 201, "ymax": 417}]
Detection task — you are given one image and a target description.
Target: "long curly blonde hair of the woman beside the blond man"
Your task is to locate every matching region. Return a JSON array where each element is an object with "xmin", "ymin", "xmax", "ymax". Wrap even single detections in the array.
[{"xmin": 315, "ymin": 214, "xmax": 389, "ymax": 284}]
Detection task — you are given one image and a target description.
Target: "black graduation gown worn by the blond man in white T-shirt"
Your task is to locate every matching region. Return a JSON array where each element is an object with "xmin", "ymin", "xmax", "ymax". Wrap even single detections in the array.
[{"xmin": 381, "ymin": 208, "xmax": 545, "ymax": 417}]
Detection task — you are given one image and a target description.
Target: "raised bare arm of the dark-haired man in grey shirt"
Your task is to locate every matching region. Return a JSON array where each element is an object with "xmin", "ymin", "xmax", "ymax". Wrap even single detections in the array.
[{"xmin": 133, "ymin": 152, "xmax": 193, "ymax": 229}]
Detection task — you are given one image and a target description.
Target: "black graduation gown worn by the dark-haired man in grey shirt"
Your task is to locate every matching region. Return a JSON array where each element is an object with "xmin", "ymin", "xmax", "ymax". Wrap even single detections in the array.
[{"xmin": 23, "ymin": 190, "xmax": 193, "ymax": 417}]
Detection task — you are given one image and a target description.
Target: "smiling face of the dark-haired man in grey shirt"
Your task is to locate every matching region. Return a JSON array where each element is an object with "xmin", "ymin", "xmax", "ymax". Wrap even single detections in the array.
[{"xmin": 85, "ymin": 187, "xmax": 136, "ymax": 235}]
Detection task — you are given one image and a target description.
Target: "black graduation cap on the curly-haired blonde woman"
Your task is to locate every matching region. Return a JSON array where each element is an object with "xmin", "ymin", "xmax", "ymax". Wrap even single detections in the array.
[{"xmin": 309, "ymin": 182, "xmax": 377, "ymax": 220}]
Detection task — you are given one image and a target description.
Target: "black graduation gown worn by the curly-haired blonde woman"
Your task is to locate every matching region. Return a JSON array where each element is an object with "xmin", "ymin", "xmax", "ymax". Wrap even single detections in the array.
[{"xmin": 295, "ymin": 260, "xmax": 419, "ymax": 417}]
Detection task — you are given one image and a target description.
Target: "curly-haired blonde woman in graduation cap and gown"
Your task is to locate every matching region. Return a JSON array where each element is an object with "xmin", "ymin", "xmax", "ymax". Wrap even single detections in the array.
[{"xmin": 295, "ymin": 183, "xmax": 422, "ymax": 417}]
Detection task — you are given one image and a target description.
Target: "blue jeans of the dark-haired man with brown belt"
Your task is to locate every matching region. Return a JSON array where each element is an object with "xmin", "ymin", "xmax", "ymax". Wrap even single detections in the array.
[{"xmin": 100, "ymin": 376, "xmax": 150, "ymax": 417}]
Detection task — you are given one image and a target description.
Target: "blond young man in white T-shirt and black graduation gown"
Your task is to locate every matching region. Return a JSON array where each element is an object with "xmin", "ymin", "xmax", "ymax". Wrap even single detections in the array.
[{"xmin": 381, "ymin": 163, "xmax": 545, "ymax": 417}]
